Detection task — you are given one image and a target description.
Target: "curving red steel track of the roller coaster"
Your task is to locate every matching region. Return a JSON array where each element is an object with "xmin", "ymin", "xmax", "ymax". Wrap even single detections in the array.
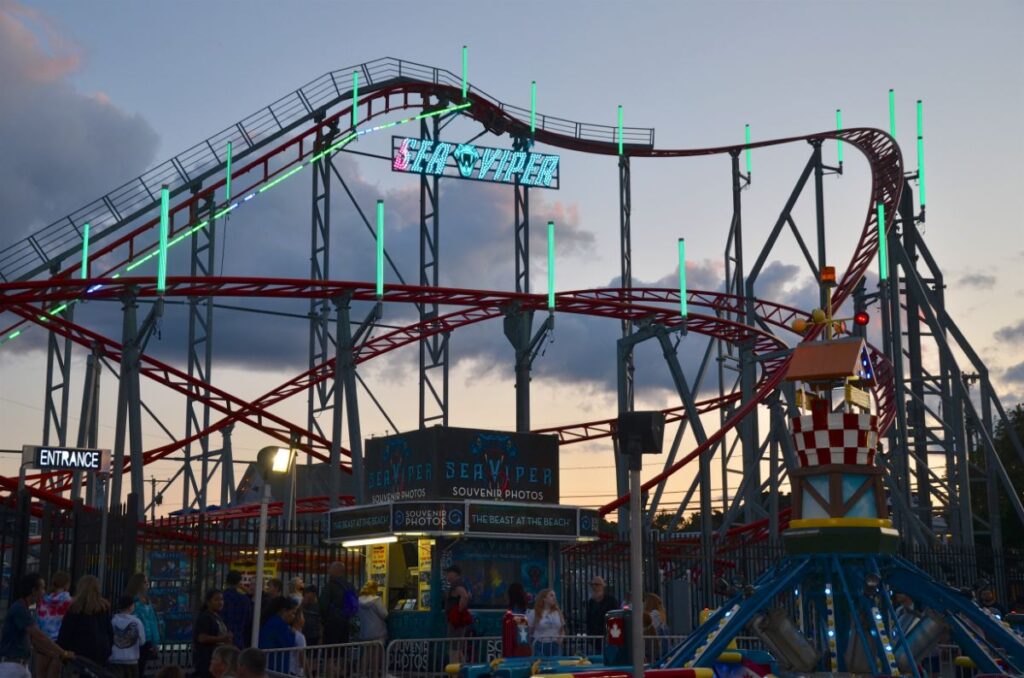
[{"xmin": 0, "ymin": 71, "xmax": 903, "ymax": 522}]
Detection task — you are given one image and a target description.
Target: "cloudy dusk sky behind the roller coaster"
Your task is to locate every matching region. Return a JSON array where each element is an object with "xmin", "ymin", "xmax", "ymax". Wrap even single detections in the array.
[{"xmin": 0, "ymin": 0, "xmax": 1024, "ymax": 516}]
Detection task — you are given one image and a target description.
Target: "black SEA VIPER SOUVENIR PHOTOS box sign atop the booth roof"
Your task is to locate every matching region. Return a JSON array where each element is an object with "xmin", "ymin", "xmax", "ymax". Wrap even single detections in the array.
[{"xmin": 364, "ymin": 426, "xmax": 559, "ymax": 504}]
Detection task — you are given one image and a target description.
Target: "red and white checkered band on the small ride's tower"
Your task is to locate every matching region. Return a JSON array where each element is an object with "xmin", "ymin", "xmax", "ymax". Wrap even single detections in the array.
[{"xmin": 793, "ymin": 412, "xmax": 879, "ymax": 466}]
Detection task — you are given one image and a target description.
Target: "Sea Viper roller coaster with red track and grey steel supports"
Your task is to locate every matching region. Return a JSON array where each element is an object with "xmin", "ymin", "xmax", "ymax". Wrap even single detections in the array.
[{"xmin": 0, "ymin": 58, "xmax": 1024, "ymax": 606}]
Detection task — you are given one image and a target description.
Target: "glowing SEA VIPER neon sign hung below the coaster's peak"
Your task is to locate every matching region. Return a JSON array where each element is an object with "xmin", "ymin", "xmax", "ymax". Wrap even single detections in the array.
[{"xmin": 391, "ymin": 136, "xmax": 559, "ymax": 188}]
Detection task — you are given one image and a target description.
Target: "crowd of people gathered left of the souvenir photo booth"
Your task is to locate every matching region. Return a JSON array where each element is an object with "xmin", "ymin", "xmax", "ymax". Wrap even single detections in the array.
[{"xmin": 0, "ymin": 563, "xmax": 364, "ymax": 678}]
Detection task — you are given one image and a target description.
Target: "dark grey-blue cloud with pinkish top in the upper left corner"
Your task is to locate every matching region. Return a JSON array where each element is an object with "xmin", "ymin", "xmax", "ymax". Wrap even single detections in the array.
[{"xmin": 0, "ymin": 0, "xmax": 158, "ymax": 240}]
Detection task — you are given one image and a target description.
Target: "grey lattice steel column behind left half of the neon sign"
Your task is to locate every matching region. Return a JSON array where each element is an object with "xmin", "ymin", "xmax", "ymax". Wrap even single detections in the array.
[{"xmin": 417, "ymin": 106, "xmax": 450, "ymax": 428}]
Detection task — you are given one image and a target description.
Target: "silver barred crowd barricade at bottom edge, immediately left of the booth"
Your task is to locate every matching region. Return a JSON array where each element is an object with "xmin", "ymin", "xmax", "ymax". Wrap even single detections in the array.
[{"xmin": 263, "ymin": 640, "xmax": 385, "ymax": 678}]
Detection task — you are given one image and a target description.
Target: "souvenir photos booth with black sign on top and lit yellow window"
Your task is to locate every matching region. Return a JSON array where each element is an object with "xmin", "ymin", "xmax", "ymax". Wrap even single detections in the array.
[{"xmin": 328, "ymin": 427, "xmax": 600, "ymax": 638}]
